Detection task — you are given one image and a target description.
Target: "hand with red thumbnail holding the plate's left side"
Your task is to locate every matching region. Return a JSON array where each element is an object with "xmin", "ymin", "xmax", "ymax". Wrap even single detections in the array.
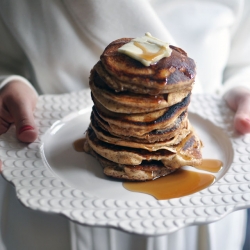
[{"xmin": 0, "ymin": 81, "xmax": 38, "ymax": 142}]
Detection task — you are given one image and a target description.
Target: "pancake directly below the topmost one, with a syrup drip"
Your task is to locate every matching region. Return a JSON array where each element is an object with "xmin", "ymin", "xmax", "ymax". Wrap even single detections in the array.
[{"xmin": 89, "ymin": 70, "xmax": 190, "ymax": 114}]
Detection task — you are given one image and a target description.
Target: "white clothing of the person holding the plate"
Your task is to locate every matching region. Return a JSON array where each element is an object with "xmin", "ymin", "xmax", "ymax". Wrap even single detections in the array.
[{"xmin": 0, "ymin": 0, "xmax": 250, "ymax": 250}]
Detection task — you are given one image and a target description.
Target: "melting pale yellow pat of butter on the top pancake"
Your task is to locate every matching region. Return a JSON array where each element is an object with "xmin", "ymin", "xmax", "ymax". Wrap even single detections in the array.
[{"xmin": 118, "ymin": 32, "xmax": 172, "ymax": 66}]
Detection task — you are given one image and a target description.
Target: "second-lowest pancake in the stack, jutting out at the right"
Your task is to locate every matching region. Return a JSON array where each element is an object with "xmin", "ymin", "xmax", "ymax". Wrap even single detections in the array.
[{"xmin": 86, "ymin": 127, "xmax": 202, "ymax": 169}]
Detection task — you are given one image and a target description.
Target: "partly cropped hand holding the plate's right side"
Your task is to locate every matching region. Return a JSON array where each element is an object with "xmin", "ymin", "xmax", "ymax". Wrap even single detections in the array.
[{"xmin": 224, "ymin": 87, "xmax": 250, "ymax": 134}]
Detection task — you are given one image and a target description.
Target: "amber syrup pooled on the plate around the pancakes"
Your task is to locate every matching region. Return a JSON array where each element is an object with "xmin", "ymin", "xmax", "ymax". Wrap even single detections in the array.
[{"xmin": 73, "ymin": 138, "xmax": 223, "ymax": 200}]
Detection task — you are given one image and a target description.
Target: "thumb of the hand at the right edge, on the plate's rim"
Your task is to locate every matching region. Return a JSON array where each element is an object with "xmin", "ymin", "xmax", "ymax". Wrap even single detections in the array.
[{"xmin": 234, "ymin": 95, "xmax": 250, "ymax": 134}]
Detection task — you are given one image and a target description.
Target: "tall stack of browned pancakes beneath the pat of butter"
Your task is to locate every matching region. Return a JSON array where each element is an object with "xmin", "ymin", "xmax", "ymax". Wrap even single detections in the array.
[{"xmin": 84, "ymin": 38, "xmax": 202, "ymax": 181}]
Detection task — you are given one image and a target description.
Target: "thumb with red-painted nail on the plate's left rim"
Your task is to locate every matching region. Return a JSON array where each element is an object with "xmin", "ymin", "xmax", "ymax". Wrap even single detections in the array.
[{"xmin": 9, "ymin": 100, "xmax": 38, "ymax": 142}]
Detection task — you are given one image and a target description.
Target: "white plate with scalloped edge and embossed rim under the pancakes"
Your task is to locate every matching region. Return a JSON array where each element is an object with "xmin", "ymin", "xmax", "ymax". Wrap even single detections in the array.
[{"xmin": 0, "ymin": 91, "xmax": 250, "ymax": 235}]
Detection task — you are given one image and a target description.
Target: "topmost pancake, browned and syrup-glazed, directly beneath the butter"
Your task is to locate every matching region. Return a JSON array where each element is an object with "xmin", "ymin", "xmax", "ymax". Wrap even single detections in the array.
[{"xmin": 98, "ymin": 38, "xmax": 196, "ymax": 95}]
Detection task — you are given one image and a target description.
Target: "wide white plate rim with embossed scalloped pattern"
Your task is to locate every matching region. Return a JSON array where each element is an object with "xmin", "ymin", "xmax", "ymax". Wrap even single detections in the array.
[{"xmin": 0, "ymin": 90, "xmax": 250, "ymax": 235}]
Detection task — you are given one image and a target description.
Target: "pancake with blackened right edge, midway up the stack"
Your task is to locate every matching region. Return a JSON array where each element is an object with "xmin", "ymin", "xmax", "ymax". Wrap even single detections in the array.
[{"xmin": 92, "ymin": 95, "xmax": 190, "ymax": 137}]
